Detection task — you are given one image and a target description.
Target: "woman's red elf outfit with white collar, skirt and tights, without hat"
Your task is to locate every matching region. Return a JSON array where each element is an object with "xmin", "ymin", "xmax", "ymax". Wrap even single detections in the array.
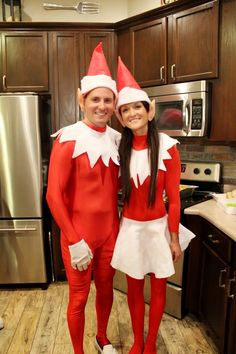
[{"xmin": 111, "ymin": 133, "xmax": 180, "ymax": 354}]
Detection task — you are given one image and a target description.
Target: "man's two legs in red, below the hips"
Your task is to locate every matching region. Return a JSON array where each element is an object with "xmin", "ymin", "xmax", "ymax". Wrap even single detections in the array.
[{"xmin": 62, "ymin": 235, "xmax": 114, "ymax": 354}]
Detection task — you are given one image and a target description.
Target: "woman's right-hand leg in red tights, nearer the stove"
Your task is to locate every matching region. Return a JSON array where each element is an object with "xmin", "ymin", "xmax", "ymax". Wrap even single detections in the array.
[{"xmin": 143, "ymin": 274, "xmax": 167, "ymax": 354}]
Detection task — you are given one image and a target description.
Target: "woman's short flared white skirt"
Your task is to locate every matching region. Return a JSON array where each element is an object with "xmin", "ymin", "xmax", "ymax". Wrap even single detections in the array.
[{"xmin": 111, "ymin": 216, "xmax": 195, "ymax": 279}]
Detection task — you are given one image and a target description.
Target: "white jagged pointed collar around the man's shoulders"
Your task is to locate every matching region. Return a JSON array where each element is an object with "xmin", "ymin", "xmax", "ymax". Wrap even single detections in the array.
[{"xmin": 52, "ymin": 121, "xmax": 120, "ymax": 168}]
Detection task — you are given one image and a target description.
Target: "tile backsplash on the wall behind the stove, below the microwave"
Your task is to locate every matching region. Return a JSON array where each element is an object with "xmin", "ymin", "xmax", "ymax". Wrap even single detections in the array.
[{"xmin": 178, "ymin": 142, "xmax": 236, "ymax": 185}]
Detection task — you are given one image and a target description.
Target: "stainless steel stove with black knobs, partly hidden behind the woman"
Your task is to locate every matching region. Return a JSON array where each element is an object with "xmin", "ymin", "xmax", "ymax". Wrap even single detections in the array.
[{"xmin": 114, "ymin": 161, "xmax": 222, "ymax": 319}]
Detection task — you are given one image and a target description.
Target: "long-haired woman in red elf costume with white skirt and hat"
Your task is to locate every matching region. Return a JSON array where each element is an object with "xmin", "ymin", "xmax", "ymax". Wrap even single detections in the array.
[{"xmin": 111, "ymin": 58, "xmax": 193, "ymax": 354}]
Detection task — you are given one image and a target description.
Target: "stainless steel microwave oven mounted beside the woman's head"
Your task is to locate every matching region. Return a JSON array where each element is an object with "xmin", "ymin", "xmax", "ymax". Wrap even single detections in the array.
[{"xmin": 144, "ymin": 80, "xmax": 211, "ymax": 137}]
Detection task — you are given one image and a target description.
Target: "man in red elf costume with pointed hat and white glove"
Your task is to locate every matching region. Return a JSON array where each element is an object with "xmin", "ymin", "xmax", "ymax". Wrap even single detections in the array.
[{"xmin": 47, "ymin": 43, "xmax": 120, "ymax": 354}]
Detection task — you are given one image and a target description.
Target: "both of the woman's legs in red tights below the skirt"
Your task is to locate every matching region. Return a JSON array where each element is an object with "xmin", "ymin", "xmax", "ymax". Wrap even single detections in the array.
[{"xmin": 127, "ymin": 274, "xmax": 167, "ymax": 354}]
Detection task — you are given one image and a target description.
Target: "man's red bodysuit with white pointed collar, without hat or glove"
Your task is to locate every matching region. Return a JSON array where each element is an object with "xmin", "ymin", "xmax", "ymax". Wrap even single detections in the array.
[{"xmin": 47, "ymin": 121, "xmax": 120, "ymax": 354}]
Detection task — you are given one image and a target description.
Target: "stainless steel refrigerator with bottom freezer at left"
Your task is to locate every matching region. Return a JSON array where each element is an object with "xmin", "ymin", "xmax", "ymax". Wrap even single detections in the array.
[{"xmin": 0, "ymin": 94, "xmax": 47, "ymax": 285}]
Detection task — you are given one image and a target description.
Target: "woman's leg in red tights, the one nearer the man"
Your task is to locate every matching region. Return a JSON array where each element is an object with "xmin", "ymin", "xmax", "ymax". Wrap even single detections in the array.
[{"xmin": 127, "ymin": 275, "xmax": 145, "ymax": 354}]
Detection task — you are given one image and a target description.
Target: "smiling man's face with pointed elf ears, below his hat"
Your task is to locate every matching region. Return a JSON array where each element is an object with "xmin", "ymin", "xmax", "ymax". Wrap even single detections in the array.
[{"xmin": 80, "ymin": 87, "xmax": 115, "ymax": 128}]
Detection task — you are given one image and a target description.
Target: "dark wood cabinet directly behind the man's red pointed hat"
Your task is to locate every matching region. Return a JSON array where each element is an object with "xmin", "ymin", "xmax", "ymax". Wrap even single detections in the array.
[{"xmin": 49, "ymin": 31, "xmax": 114, "ymax": 131}]
